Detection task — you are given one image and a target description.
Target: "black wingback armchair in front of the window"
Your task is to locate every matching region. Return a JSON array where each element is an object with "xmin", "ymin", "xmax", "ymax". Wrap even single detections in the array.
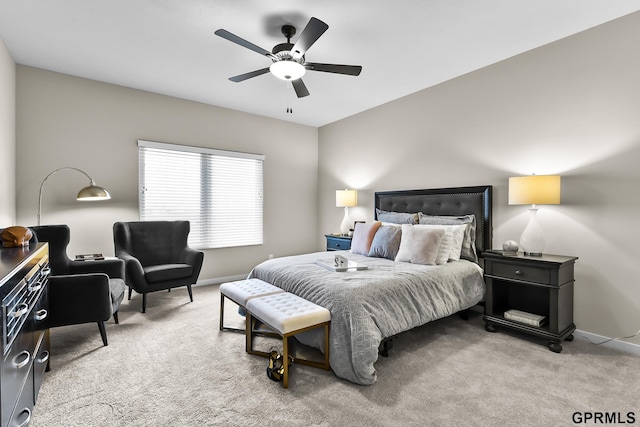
[{"xmin": 113, "ymin": 221, "xmax": 204, "ymax": 313}]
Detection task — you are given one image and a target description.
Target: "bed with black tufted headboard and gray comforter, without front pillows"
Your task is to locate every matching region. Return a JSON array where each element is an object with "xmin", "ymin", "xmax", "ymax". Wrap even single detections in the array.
[{"xmin": 250, "ymin": 186, "xmax": 492, "ymax": 385}]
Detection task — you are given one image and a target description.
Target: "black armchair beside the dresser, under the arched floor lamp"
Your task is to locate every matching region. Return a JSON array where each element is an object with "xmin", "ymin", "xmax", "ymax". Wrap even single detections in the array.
[{"xmin": 29, "ymin": 225, "xmax": 125, "ymax": 345}]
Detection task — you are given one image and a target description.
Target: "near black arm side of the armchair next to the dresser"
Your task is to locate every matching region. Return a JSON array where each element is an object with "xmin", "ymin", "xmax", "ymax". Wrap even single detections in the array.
[{"xmin": 47, "ymin": 273, "xmax": 112, "ymax": 327}]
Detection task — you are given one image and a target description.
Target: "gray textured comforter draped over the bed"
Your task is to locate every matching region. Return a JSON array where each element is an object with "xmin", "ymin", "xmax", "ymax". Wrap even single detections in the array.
[{"xmin": 250, "ymin": 251, "xmax": 485, "ymax": 384}]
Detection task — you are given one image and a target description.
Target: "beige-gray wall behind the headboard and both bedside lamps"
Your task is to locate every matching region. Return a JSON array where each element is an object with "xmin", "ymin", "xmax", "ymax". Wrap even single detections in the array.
[{"xmin": 319, "ymin": 13, "xmax": 640, "ymax": 343}]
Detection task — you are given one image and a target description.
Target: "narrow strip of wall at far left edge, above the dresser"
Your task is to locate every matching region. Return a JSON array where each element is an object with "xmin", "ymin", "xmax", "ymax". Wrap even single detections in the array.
[{"xmin": 0, "ymin": 38, "xmax": 16, "ymax": 228}]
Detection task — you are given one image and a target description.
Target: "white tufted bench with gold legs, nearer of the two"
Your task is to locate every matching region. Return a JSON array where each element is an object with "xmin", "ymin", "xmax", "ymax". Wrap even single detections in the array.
[{"xmin": 245, "ymin": 292, "xmax": 331, "ymax": 388}]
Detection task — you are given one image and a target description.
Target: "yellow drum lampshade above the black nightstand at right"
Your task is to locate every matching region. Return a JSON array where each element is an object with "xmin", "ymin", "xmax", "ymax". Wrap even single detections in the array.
[{"xmin": 509, "ymin": 175, "xmax": 560, "ymax": 205}]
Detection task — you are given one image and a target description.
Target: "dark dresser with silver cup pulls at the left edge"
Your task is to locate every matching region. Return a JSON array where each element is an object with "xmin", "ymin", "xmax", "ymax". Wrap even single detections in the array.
[{"xmin": 0, "ymin": 243, "xmax": 51, "ymax": 427}]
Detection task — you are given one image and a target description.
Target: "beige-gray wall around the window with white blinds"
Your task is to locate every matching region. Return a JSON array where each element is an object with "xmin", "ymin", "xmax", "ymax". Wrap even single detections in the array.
[{"xmin": 17, "ymin": 65, "xmax": 318, "ymax": 280}]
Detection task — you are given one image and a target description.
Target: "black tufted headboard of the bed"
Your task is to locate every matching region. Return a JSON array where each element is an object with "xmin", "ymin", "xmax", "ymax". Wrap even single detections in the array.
[{"xmin": 374, "ymin": 185, "xmax": 493, "ymax": 254}]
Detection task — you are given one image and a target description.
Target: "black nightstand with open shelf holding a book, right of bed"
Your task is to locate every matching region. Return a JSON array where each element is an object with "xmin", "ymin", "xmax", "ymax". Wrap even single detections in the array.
[{"xmin": 482, "ymin": 252, "xmax": 578, "ymax": 353}]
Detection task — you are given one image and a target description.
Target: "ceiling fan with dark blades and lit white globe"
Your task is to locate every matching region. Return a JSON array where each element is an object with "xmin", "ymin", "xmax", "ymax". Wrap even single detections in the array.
[{"xmin": 215, "ymin": 18, "xmax": 362, "ymax": 98}]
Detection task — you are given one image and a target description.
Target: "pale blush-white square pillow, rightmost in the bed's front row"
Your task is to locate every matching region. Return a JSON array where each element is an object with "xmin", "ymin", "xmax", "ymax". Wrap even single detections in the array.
[{"xmin": 395, "ymin": 224, "xmax": 445, "ymax": 265}]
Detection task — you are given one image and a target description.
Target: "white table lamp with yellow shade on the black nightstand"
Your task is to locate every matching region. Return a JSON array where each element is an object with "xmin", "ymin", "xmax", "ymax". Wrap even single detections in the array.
[{"xmin": 509, "ymin": 175, "xmax": 560, "ymax": 256}]
